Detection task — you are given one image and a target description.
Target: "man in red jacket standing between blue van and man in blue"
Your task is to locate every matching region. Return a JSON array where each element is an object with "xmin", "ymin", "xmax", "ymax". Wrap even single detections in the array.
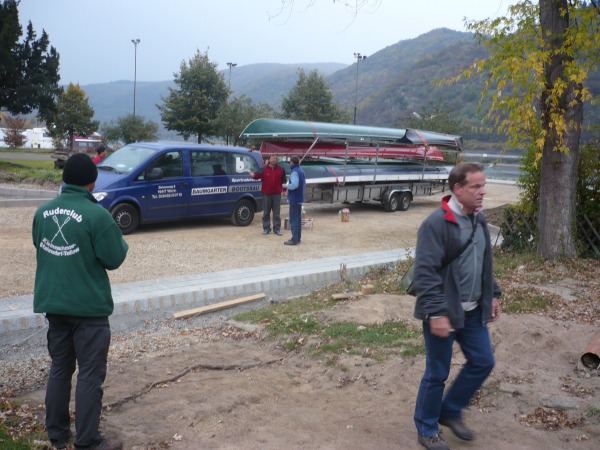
[{"xmin": 250, "ymin": 155, "xmax": 285, "ymax": 236}]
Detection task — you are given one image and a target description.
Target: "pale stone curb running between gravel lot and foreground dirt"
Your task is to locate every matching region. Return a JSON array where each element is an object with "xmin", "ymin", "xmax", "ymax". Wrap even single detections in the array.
[{"xmin": 0, "ymin": 249, "xmax": 410, "ymax": 335}]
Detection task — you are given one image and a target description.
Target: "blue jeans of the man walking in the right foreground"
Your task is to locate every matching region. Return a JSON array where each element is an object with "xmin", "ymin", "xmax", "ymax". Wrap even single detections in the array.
[{"xmin": 414, "ymin": 308, "xmax": 494, "ymax": 436}]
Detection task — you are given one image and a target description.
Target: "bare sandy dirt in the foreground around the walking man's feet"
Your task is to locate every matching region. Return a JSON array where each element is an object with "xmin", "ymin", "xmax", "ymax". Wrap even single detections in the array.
[{"xmin": 11, "ymin": 295, "xmax": 600, "ymax": 450}]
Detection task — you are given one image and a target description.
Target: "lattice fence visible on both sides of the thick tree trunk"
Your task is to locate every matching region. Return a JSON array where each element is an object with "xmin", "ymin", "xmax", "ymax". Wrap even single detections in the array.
[{"xmin": 501, "ymin": 208, "xmax": 600, "ymax": 258}]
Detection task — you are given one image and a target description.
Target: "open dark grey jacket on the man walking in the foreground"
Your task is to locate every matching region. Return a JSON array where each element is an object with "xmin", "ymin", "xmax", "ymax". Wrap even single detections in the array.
[{"xmin": 413, "ymin": 195, "xmax": 501, "ymax": 329}]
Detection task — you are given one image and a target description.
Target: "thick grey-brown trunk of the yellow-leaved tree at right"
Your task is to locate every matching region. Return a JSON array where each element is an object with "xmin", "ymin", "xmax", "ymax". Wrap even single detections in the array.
[{"xmin": 538, "ymin": 0, "xmax": 583, "ymax": 260}]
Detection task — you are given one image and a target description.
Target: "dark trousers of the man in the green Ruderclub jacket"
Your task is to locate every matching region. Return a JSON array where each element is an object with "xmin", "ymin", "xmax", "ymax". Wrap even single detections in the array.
[{"xmin": 46, "ymin": 314, "xmax": 110, "ymax": 448}]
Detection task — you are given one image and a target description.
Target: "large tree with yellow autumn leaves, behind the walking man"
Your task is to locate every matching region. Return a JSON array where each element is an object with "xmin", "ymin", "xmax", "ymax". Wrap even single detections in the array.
[{"xmin": 454, "ymin": 0, "xmax": 600, "ymax": 259}]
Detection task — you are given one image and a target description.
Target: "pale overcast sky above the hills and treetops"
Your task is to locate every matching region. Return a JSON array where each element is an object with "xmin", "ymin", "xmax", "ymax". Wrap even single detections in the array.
[{"xmin": 16, "ymin": 0, "xmax": 514, "ymax": 85}]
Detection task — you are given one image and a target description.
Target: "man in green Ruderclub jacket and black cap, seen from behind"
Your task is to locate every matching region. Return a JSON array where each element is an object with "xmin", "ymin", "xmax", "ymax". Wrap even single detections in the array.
[{"xmin": 32, "ymin": 153, "xmax": 128, "ymax": 450}]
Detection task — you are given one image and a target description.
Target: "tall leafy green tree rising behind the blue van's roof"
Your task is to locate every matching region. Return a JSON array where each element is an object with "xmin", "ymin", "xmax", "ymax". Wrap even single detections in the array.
[{"xmin": 157, "ymin": 51, "xmax": 229, "ymax": 142}]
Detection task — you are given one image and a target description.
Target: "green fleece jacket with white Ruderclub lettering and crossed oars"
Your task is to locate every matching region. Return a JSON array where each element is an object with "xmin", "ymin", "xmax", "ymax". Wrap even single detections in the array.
[{"xmin": 32, "ymin": 184, "xmax": 129, "ymax": 317}]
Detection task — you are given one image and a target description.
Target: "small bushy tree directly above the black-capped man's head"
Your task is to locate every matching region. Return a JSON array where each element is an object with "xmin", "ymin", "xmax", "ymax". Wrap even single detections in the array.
[{"xmin": 47, "ymin": 83, "xmax": 100, "ymax": 149}]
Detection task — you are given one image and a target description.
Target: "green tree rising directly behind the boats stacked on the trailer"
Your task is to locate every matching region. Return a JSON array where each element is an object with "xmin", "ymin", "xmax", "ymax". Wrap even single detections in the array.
[{"xmin": 281, "ymin": 69, "xmax": 350, "ymax": 123}]
